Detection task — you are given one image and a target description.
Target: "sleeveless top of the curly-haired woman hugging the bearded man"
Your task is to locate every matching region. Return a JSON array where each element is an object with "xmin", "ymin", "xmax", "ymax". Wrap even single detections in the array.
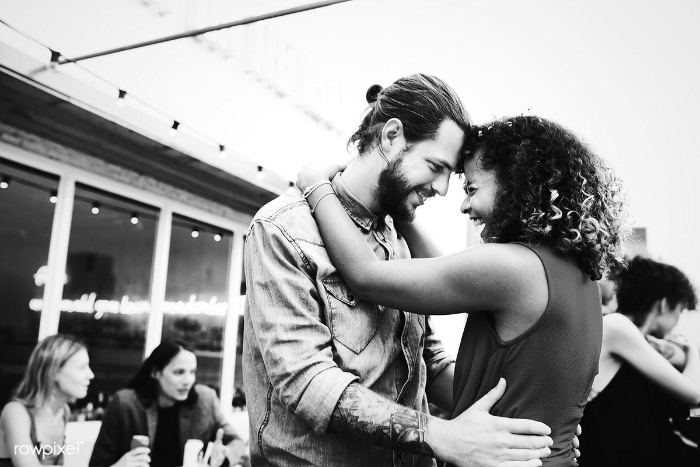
[{"xmin": 452, "ymin": 245, "xmax": 603, "ymax": 466}]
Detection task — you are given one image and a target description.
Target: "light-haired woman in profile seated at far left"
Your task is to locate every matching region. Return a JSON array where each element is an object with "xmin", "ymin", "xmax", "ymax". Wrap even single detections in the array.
[{"xmin": 0, "ymin": 334, "xmax": 95, "ymax": 467}]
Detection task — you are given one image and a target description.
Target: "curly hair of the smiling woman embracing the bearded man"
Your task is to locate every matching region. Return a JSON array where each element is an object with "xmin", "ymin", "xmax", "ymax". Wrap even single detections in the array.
[{"xmin": 460, "ymin": 116, "xmax": 629, "ymax": 280}]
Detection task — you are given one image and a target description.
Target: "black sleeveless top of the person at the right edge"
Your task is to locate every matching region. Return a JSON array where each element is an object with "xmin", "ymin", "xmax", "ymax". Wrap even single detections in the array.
[{"xmin": 579, "ymin": 363, "xmax": 700, "ymax": 467}]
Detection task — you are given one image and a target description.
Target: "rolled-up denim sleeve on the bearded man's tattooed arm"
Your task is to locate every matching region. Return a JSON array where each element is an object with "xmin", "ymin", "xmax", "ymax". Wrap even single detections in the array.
[{"xmin": 245, "ymin": 219, "xmax": 358, "ymax": 433}]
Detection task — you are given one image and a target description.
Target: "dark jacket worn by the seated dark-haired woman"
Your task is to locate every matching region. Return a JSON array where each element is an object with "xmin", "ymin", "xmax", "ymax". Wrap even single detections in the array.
[{"xmin": 90, "ymin": 384, "xmax": 237, "ymax": 467}]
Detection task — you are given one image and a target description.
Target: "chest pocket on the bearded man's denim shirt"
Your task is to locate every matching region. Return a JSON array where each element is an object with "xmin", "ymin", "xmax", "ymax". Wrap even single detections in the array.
[{"xmin": 322, "ymin": 276, "xmax": 379, "ymax": 354}]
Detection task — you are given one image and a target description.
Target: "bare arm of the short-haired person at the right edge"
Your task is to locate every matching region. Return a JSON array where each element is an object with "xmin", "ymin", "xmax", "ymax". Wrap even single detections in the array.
[{"xmin": 603, "ymin": 313, "xmax": 700, "ymax": 405}]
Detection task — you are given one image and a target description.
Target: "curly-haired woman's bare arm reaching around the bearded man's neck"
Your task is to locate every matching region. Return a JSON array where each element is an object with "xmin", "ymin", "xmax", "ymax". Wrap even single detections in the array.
[{"xmin": 307, "ymin": 185, "xmax": 547, "ymax": 314}]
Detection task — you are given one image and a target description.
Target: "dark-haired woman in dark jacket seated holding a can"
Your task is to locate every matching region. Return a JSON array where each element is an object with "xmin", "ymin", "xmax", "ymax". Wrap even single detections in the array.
[{"xmin": 90, "ymin": 341, "xmax": 247, "ymax": 467}]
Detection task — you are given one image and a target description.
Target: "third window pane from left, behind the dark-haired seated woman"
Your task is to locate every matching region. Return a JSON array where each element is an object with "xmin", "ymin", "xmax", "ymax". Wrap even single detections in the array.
[{"xmin": 162, "ymin": 214, "xmax": 233, "ymax": 391}]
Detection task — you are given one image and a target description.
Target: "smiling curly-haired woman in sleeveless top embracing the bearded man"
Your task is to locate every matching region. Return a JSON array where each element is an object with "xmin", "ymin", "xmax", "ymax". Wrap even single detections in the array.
[{"xmin": 297, "ymin": 116, "xmax": 624, "ymax": 466}]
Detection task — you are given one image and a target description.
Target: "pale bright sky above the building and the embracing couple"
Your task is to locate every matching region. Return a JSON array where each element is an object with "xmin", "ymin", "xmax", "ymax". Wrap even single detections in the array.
[{"xmin": 0, "ymin": 0, "xmax": 700, "ymax": 294}]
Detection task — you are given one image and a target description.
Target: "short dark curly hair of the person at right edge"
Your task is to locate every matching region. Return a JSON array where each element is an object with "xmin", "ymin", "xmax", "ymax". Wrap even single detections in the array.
[{"xmin": 612, "ymin": 256, "xmax": 697, "ymax": 325}]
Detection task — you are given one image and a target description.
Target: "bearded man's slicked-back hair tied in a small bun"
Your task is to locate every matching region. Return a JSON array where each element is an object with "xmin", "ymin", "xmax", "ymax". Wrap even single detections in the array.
[{"xmin": 348, "ymin": 73, "xmax": 471, "ymax": 154}]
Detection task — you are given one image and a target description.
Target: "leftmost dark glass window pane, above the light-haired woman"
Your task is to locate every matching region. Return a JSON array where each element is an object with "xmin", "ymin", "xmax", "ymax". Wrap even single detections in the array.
[{"xmin": 0, "ymin": 159, "xmax": 58, "ymax": 406}]
